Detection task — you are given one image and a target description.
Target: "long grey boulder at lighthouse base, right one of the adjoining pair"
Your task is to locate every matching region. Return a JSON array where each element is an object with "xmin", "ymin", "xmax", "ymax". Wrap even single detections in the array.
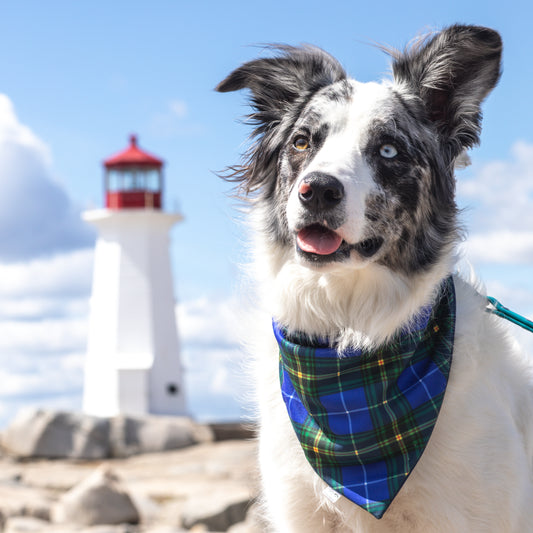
[{"xmin": 111, "ymin": 416, "xmax": 213, "ymax": 457}]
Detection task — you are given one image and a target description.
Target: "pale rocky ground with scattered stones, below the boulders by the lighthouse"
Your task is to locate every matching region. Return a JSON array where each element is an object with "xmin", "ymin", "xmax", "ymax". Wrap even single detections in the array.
[{"xmin": 0, "ymin": 412, "xmax": 264, "ymax": 533}]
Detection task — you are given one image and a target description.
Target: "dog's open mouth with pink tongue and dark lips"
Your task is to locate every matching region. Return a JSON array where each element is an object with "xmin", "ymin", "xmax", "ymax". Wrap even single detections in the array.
[{"xmin": 296, "ymin": 224, "xmax": 383, "ymax": 261}]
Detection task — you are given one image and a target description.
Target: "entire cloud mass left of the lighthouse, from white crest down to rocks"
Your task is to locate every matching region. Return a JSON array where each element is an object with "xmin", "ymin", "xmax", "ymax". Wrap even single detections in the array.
[{"xmin": 0, "ymin": 103, "xmax": 94, "ymax": 424}]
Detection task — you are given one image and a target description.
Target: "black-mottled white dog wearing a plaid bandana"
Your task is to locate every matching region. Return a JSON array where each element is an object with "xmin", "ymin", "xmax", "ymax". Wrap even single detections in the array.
[{"xmin": 217, "ymin": 25, "xmax": 533, "ymax": 533}]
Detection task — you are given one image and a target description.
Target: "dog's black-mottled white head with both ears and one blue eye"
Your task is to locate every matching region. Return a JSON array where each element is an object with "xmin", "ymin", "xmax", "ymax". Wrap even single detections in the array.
[{"xmin": 217, "ymin": 26, "xmax": 502, "ymax": 275}]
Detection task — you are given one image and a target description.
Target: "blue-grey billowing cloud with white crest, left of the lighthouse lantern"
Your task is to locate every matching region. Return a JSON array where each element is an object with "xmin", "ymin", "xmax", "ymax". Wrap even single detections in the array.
[{"xmin": 0, "ymin": 95, "xmax": 93, "ymax": 262}]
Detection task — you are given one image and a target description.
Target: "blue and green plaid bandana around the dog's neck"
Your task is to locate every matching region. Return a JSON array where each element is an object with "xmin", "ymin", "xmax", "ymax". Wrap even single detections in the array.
[{"xmin": 274, "ymin": 277, "xmax": 455, "ymax": 518}]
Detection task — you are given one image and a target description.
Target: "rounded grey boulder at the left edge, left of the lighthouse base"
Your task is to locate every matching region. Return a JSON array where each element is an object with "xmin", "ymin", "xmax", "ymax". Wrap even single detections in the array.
[{"xmin": 2, "ymin": 409, "xmax": 110, "ymax": 459}]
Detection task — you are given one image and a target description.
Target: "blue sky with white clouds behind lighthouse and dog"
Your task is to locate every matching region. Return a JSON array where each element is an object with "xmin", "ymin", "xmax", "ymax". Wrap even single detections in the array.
[{"xmin": 0, "ymin": 0, "xmax": 533, "ymax": 426}]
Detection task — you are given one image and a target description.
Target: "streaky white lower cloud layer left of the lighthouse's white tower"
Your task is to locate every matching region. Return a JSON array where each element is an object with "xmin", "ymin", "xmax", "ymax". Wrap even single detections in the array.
[{"xmin": 0, "ymin": 250, "xmax": 92, "ymax": 425}]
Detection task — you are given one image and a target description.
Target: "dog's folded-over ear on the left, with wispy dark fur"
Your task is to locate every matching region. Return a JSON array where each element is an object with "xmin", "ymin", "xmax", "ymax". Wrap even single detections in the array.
[{"xmin": 216, "ymin": 46, "xmax": 346, "ymax": 194}]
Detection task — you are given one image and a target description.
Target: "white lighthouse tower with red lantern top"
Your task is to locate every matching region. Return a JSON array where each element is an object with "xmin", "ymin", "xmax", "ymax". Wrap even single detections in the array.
[{"xmin": 83, "ymin": 136, "xmax": 186, "ymax": 417}]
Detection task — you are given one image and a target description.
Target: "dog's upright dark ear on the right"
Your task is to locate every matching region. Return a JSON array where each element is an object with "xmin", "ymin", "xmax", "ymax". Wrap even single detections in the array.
[{"xmin": 392, "ymin": 25, "xmax": 502, "ymax": 158}]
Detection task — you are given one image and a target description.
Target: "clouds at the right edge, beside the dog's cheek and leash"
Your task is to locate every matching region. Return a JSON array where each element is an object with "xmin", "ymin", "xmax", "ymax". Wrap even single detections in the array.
[{"xmin": 458, "ymin": 142, "xmax": 533, "ymax": 353}]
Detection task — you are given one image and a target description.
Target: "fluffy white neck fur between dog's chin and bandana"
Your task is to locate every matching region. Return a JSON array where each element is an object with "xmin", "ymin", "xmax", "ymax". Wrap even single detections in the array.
[{"xmin": 254, "ymin": 202, "xmax": 454, "ymax": 351}]
